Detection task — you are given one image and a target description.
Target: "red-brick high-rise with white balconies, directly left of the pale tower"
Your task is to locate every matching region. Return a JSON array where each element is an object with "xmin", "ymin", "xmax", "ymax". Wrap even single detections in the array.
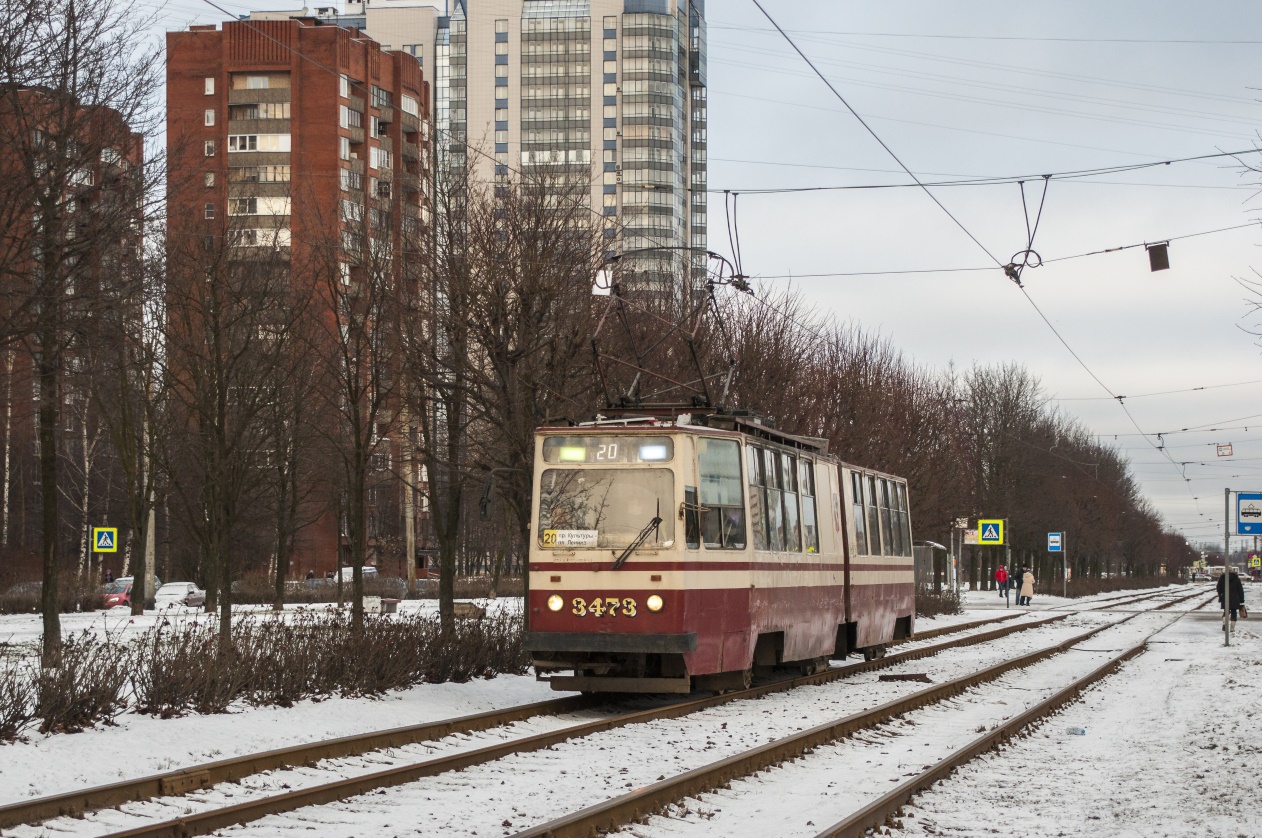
[{"xmin": 167, "ymin": 18, "xmax": 432, "ymax": 578}]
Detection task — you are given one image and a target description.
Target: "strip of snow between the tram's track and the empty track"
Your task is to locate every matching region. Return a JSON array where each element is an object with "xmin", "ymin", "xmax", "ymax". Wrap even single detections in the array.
[{"xmin": 140, "ymin": 615, "xmax": 1117, "ymax": 837}]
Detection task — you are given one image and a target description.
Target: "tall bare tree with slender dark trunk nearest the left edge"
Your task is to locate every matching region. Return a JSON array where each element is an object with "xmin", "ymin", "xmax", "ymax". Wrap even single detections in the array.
[{"xmin": 0, "ymin": 0, "xmax": 160, "ymax": 660}]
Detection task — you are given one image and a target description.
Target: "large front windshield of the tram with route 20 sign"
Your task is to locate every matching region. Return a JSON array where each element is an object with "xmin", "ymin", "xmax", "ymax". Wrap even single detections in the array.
[{"xmin": 538, "ymin": 468, "xmax": 675, "ymax": 549}]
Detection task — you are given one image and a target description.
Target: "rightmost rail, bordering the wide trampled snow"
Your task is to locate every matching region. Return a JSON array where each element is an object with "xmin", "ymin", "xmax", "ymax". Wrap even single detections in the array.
[{"xmin": 815, "ymin": 594, "xmax": 1217, "ymax": 838}]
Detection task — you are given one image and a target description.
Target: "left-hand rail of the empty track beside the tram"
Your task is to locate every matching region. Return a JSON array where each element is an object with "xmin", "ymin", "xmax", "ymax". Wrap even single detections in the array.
[{"xmin": 512, "ymin": 588, "xmax": 1211, "ymax": 838}]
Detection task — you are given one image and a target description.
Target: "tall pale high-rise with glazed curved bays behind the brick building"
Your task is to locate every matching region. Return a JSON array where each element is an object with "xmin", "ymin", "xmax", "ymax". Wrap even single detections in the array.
[{"xmin": 244, "ymin": 0, "xmax": 707, "ymax": 298}]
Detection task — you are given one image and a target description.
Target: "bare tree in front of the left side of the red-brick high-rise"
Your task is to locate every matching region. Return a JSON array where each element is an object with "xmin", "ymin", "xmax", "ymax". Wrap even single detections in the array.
[{"xmin": 163, "ymin": 225, "xmax": 295, "ymax": 654}]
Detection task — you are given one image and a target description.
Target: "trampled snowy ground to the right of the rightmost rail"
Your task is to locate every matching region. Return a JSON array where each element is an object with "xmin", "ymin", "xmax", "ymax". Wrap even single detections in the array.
[{"xmin": 899, "ymin": 608, "xmax": 1262, "ymax": 838}]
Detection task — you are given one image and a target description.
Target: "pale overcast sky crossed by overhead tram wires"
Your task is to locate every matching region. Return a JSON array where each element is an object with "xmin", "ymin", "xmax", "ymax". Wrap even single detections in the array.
[{"xmin": 147, "ymin": 0, "xmax": 1262, "ymax": 544}]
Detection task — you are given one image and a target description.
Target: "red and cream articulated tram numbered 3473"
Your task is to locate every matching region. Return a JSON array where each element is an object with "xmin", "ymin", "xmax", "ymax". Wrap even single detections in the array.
[{"xmin": 526, "ymin": 414, "xmax": 915, "ymax": 693}]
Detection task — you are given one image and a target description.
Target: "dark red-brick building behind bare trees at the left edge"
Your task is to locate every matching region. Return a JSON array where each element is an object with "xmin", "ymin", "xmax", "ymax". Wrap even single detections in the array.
[{"xmin": 0, "ymin": 87, "xmax": 144, "ymax": 578}]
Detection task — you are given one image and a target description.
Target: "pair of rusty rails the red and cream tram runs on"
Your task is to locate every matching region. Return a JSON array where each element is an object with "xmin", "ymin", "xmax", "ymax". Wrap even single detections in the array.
[{"xmin": 0, "ymin": 593, "xmax": 1196, "ymax": 835}]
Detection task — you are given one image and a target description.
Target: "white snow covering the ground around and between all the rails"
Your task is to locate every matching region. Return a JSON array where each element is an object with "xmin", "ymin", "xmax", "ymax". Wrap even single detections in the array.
[{"xmin": 0, "ymin": 588, "xmax": 1231, "ymax": 838}]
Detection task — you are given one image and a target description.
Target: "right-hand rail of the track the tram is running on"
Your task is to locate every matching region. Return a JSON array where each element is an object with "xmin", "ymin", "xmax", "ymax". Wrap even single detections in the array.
[{"xmin": 71, "ymin": 613, "xmax": 1070, "ymax": 838}]
